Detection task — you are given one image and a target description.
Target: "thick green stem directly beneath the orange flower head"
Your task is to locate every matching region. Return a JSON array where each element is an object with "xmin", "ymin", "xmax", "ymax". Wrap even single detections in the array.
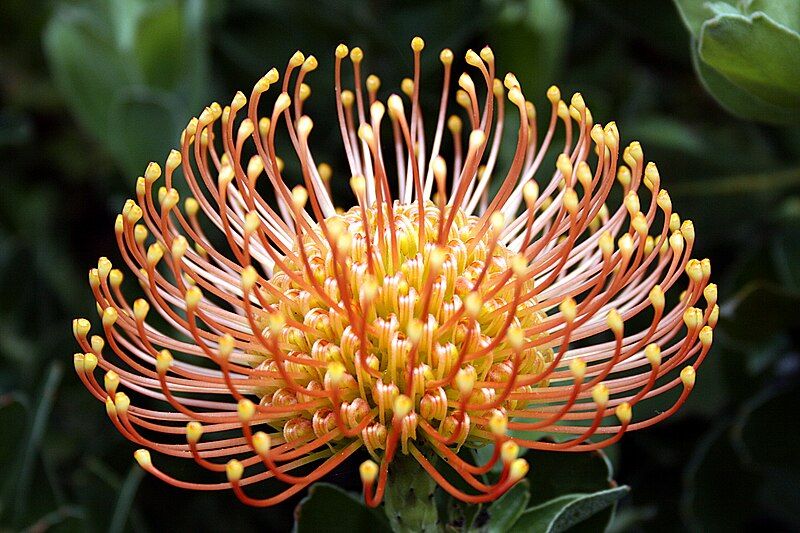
[{"xmin": 384, "ymin": 448, "xmax": 438, "ymax": 532}]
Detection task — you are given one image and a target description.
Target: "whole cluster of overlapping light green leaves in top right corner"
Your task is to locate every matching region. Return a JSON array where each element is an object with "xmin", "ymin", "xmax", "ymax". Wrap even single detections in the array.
[{"xmin": 675, "ymin": 0, "xmax": 800, "ymax": 123}]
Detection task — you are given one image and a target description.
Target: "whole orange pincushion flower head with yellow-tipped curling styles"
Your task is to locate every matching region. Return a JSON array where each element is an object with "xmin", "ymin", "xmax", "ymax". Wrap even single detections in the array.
[{"xmin": 73, "ymin": 38, "xmax": 719, "ymax": 506}]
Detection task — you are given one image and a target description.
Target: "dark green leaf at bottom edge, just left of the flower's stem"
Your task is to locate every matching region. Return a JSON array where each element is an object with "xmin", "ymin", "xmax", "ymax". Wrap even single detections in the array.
[{"xmin": 294, "ymin": 483, "xmax": 391, "ymax": 533}]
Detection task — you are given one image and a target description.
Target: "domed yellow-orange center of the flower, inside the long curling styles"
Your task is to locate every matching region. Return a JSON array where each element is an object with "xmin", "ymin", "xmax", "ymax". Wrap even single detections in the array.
[{"xmin": 253, "ymin": 202, "xmax": 553, "ymax": 450}]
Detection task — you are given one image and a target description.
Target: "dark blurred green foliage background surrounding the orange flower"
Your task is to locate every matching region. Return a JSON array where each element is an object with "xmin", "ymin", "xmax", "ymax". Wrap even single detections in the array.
[{"xmin": 0, "ymin": 0, "xmax": 800, "ymax": 532}]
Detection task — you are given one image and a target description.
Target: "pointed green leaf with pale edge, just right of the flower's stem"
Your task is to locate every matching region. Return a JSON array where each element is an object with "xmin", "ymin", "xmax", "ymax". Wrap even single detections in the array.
[{"xmin": 513, "ymin": 486, "xmax": 630, "ymax": 533}]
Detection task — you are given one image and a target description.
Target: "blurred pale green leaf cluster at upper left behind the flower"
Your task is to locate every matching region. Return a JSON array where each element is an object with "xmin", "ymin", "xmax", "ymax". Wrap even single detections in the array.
[{"xmin": 44, "ymin": 0, "xmax": 208, "ymax": 173}]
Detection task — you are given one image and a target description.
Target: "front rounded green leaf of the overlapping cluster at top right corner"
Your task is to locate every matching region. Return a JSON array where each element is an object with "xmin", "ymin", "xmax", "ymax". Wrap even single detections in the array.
[{"xmin": 698, "ymin": 13, "xmax": 800, "ymax": 112}]
